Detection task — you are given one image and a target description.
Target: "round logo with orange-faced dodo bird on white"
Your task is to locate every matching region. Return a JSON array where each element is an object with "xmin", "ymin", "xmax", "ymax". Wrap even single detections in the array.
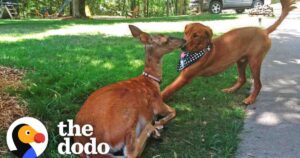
[{"xmin": 6, "ymin": 117, "xmax": 48, "ymax": 158}]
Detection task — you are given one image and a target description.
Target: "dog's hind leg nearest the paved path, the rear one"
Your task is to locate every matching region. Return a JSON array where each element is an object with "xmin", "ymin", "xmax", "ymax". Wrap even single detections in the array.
[{"xmin": 243, "ymin": 57, "xmax": 263, "ymax": 105}]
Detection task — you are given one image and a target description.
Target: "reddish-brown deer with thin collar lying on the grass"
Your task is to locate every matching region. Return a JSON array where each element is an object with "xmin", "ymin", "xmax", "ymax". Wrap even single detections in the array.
[{"xmin": 74, "ymin": 25, "xmax": 185, "ymax": 158}]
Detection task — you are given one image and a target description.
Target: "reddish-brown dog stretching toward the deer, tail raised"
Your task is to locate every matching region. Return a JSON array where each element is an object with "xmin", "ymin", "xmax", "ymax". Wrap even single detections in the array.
[{"xmin": 162, "ymin": 0, "xmax": 296, "ymax": 104}]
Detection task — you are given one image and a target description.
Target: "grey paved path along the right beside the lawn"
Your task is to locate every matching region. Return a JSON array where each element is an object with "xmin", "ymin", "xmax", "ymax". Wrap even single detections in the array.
[{"xmin": 236, "ymin": 2, "xmax": 300, "ymax": 158}]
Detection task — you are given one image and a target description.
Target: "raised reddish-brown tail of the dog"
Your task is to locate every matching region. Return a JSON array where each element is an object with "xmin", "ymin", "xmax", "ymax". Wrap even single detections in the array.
[{"xmin": 266, "ymin": 0, "xmax": 297, "ymax": 34}]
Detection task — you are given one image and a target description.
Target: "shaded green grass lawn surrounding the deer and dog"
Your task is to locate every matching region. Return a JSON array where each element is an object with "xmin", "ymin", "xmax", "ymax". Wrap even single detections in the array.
[{"xmin": 0, "ymin": 14, "xmax": 249, "ymax": 158}]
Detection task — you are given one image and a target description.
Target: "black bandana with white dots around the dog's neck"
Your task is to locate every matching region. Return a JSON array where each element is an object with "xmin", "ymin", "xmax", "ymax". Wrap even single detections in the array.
[{"xmin": 177, "ymin": 44, "xmax": 211, "ymax": 71}]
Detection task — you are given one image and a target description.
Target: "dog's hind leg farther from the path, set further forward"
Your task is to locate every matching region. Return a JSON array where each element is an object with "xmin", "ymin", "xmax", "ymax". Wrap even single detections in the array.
[{"xmin": 222, "ymin": 58, "xmax": 248, "ymax": 93}]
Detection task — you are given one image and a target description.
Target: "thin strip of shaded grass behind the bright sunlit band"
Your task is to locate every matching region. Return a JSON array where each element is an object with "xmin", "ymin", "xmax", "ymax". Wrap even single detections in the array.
[{"xmin": 0, "ymin": 14, "xmax": 237, "ymax": 36}]
